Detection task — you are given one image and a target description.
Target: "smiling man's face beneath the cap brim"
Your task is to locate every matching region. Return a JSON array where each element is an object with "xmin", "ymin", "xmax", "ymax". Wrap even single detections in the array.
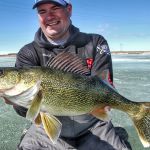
[{"xmin": 37, "ymin": 3, "xmax": 72, "ymax": 40}]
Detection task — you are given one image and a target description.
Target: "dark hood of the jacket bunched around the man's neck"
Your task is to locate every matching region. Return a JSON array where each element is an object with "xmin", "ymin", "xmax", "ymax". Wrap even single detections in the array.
[{"xmin": 34, "ymin": 25, "xmax": 79, "ymax": 48}]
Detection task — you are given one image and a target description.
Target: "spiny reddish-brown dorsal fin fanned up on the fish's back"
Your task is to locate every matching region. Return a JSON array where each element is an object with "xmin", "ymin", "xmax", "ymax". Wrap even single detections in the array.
[{"xmin": 47, "ymin": 52, "xmax": 90, "ymax": 75}]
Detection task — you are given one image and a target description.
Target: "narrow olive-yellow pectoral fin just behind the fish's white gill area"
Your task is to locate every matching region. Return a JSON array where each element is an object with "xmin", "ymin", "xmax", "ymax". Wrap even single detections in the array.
[{"xmin": 26, "ymin": 90, "xmax": 43, "ymax": 121}]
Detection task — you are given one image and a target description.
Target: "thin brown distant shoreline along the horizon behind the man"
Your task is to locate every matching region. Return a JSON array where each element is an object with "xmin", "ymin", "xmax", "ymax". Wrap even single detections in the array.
[{"xmin": 0, "ymin": 51, "xmax": 150, "ymax": 57}]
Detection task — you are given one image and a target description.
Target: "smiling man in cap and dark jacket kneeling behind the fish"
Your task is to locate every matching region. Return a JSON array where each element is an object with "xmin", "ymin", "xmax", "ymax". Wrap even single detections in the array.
[{"xmin": 6, "ymin": 0, "xmax": 130, "ymax": 150}]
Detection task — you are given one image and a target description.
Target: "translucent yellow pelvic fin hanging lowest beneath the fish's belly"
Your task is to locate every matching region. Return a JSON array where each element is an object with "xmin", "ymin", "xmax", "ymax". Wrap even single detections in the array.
[{"xmin": 40, "ymin": 112, "xmax": 62, "ymax": 144}]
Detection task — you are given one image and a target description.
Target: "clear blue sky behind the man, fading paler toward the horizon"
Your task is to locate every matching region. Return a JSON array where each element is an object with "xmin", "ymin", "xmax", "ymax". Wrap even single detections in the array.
[{"xmin": 0, "ymin": 0, "xmax": 150, "ymax": 53}]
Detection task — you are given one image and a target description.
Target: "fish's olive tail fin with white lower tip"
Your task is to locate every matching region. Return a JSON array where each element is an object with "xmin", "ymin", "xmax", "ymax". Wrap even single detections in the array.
[{"xmin": 132, "ymin": 102, "xmax": 150, "ymax": 147}]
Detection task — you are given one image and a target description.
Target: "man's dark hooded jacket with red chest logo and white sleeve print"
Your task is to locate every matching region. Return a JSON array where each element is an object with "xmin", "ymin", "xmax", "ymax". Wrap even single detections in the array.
[{"xmin": 15, "ymin": 25, "xmax": 113, "ymax": 137}]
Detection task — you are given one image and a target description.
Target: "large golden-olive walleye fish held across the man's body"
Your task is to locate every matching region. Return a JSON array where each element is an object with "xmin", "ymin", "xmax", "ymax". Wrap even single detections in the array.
[{"xmin": 0, "ymin": 52, "xmax": 150, "ymax": 147}]
